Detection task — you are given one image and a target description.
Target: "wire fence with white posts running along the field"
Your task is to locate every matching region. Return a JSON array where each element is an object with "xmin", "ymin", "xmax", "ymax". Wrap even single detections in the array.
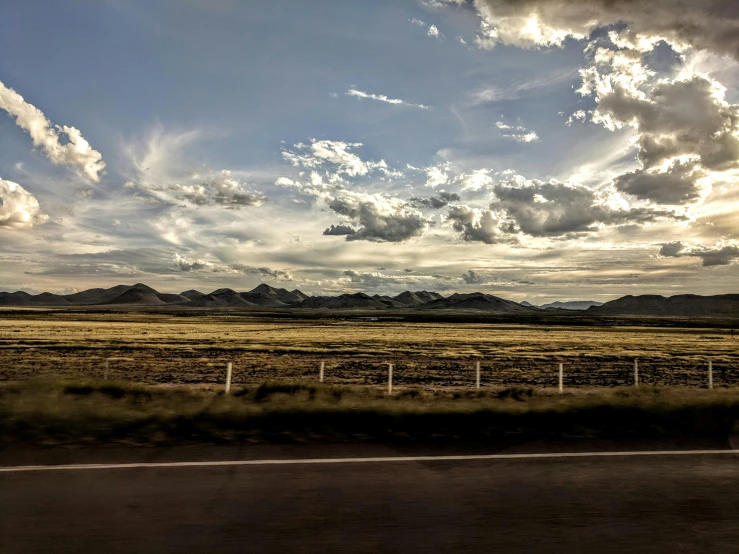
[{"xmin": 0, "ymin": 356, "xmax": 739, "ymax": 388}]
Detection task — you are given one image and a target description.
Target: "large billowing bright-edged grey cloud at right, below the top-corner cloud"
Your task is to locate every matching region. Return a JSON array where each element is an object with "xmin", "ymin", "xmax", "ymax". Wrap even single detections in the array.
[{"xmin": 579, "ymin": 48, "xmax": 739, "ymax": 204}]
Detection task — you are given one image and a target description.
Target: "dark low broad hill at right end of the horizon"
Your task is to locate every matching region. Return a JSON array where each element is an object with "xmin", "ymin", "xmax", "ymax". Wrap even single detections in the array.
[{"xmin": 587, "ymin": 294, "xmax": 739, "ymax": 317}]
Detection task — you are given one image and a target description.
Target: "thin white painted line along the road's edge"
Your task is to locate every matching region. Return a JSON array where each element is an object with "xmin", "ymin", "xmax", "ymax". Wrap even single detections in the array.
[{"xmin": 0, "ymin": 450, "xmax": 739, "ymax": 473}]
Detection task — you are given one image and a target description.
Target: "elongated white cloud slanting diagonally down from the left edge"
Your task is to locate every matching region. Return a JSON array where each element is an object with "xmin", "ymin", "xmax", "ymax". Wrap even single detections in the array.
[{"xmin": 0, "ymin": 82, "xmax": 105, "ymax": 182}]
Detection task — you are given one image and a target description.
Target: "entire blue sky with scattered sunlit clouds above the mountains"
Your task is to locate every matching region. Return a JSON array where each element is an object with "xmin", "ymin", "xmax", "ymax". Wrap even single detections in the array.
[{"xmin": 0, "ymin": 0, "xmax": 739, "ymax": 303}]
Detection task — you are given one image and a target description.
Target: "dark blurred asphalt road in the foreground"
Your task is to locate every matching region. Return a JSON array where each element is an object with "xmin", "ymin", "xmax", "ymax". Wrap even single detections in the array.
[{"xmin": 0, "ymin": 447, "xmax": 739, "ymax": 554}]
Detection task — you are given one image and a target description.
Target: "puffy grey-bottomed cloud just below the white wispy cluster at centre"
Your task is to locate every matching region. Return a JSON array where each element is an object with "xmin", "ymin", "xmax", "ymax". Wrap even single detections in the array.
[{"xmin": 327, "ymin": 191, "xmax": 429, "ymax": 242}]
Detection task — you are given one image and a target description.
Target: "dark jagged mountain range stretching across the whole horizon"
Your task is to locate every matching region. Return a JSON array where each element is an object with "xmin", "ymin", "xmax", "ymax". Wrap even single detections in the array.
[{"xmin": 0, "ymin": 283, "xmax": 739, "ymax": 317}]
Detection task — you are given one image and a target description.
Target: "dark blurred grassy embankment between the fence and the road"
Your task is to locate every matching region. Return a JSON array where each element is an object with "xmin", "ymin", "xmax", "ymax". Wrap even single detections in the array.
[{"xmin": 0, "ymin": 380, "xmax": 739, "ymax": 445}]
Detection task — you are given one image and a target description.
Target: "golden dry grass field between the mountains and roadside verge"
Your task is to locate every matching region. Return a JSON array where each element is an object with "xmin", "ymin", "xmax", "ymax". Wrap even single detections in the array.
[{"xmin": 0, "ymin": 311, "xmax": 739, "ymax": 389}]
